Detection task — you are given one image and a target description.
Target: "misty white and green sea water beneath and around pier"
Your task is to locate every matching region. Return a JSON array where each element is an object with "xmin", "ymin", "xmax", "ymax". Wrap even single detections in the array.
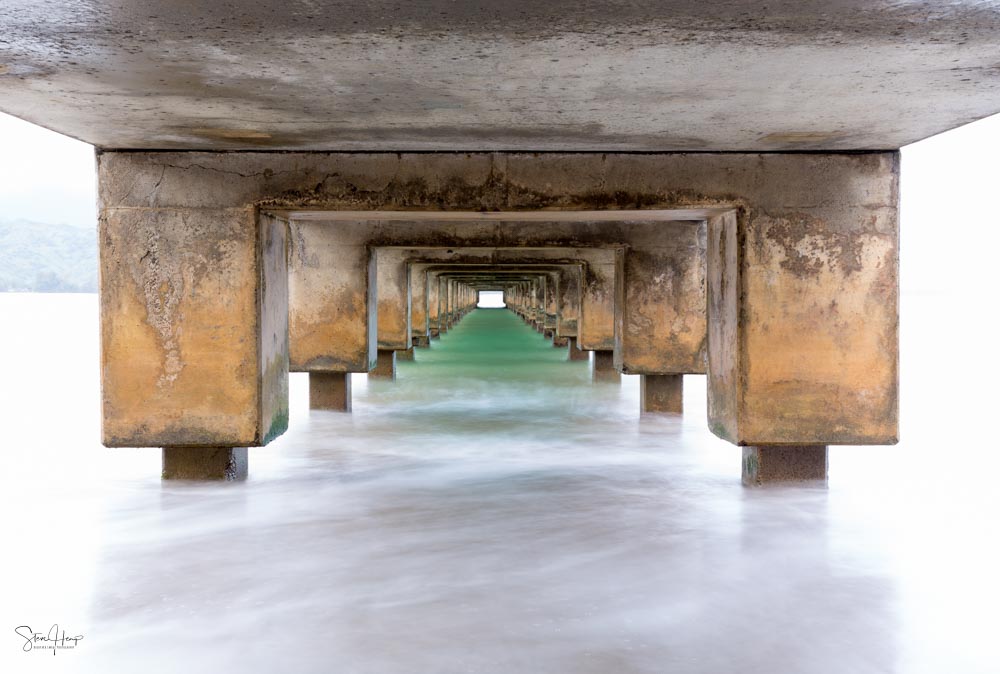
[{"xmin": 0, "ymin": 295, "xmax": 1000, "ymax": 674}]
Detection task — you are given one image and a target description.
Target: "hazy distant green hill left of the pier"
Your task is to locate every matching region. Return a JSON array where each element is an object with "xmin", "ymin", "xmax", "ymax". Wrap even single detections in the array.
[{"xmin": 0, "ymin": 220, "xmax": 97, "ymax": 293}]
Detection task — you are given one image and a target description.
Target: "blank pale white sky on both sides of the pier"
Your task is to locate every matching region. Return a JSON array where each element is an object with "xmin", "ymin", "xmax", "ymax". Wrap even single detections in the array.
[{"xmin": 0, "ymin": 113, "xmax": 1000, "ymax": 296}]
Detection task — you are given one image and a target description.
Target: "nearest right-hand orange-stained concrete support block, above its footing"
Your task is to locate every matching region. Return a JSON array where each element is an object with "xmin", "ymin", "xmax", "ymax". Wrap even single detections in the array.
[{"xmin": 708, "ymin": 154, "xmax": 899, "ymax": 445}]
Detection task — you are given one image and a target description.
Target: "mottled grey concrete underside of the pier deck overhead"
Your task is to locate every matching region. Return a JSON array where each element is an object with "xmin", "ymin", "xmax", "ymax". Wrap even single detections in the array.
[{"xmin": 0, "ymin": 0, "xmax": 1000, "ymax": 151}]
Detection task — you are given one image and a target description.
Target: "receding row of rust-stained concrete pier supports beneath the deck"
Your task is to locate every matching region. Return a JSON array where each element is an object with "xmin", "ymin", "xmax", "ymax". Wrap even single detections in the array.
[{"xmin": 98, "ymin": 152, "xmax": 899, "ymax": 482}]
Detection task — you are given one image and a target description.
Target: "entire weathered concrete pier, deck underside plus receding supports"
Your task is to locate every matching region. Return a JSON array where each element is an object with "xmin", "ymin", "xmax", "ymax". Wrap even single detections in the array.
[{"xmin": 0, "ymin": 0, "xmax": 1000, "ymax": 483}]
